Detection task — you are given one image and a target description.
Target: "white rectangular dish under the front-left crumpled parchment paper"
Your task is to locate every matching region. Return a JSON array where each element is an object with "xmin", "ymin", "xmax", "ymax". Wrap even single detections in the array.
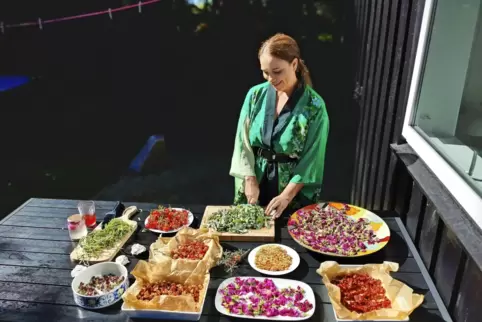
[{"xmin": 121, "ymin": 282, "xmax": 209, "ymax": 321}]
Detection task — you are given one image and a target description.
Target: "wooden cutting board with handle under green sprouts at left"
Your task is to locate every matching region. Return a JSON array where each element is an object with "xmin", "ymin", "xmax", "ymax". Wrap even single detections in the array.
[{"xmin": 70, "ymin": 206, "xmax": 139, "ymax": 263}]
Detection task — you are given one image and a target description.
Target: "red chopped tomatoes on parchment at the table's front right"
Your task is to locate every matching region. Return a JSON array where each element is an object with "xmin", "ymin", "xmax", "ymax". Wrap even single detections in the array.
[{"xmin": 332, "ymin": 274, "xmax": 392, "ymax": 313}]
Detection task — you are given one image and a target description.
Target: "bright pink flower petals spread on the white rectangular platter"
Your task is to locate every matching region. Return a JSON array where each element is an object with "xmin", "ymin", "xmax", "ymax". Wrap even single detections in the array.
[{"xmin": 219, "ymin": 277, "xmax": 313, "ymax": 317}]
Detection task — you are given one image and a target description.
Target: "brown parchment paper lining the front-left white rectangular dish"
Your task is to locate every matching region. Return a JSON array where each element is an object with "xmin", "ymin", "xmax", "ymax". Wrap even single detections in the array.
[{"xmin": 122, "ymin": 260, "xmax": 209, "ymax": 312}]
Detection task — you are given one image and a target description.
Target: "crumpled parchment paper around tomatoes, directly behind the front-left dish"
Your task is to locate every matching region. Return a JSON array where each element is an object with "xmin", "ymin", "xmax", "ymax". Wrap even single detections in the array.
[{"xmin": 149, "ymin": 227, "xmax": 223, "ymax": 274}]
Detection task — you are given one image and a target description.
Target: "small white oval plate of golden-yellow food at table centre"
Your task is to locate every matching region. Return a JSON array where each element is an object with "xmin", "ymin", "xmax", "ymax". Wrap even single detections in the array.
[{"xmin": 248, "ymin": 244, "xmax": 300, "ymax": 276}]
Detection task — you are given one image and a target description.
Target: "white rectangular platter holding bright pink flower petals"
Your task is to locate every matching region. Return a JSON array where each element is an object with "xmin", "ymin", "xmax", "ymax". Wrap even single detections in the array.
[{"xmin": 214, "ymin": 276, "xmax": 316, "ymax": 321}]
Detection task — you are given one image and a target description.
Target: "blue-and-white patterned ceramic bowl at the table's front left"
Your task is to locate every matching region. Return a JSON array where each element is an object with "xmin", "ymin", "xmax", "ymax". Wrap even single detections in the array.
[{"xmin": 72, "ymin": 262, "xmax": 129, "ymax": 310}]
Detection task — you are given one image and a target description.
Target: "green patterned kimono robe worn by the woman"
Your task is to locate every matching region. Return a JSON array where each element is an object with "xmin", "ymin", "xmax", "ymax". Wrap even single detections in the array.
[{"xmin": 230, "ymin": 82, "xmax": 329, "ymax": 208}]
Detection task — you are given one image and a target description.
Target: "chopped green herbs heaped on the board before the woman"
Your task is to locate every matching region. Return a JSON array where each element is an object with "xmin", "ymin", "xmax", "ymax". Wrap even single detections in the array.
[{"xmin": 206, "ymin": 205, "xmax": 271, "ymax": 234}]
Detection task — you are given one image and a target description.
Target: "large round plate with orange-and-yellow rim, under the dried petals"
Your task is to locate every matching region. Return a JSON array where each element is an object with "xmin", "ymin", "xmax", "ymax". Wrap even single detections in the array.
[{"xmin": 288, "ymin": 202, "xmax": 390, "ymax": 257}]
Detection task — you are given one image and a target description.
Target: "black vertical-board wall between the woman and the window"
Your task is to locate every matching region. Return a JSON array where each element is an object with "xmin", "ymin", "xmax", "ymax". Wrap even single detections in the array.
[{"xmin": 352, "ymin": 0, "xmax": 425, "ymax": 210}]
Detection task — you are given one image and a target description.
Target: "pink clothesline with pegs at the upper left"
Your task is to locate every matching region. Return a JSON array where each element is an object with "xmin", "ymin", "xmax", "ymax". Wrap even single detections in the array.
[{"xmin": 0, "ymin": 0, "xmax": 161, "ymax": 34}]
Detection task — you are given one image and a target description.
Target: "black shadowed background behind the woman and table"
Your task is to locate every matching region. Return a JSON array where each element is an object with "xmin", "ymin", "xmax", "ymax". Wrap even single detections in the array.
[{"xmin": 0, "ymin": 0, "xmax": 359, "ymax": 215}]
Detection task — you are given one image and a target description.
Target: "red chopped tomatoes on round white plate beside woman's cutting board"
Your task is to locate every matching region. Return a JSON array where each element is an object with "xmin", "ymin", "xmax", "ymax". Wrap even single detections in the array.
[{"xmin": 146, "ymin": 207, "xmax": 189, "ymax": 231}]
